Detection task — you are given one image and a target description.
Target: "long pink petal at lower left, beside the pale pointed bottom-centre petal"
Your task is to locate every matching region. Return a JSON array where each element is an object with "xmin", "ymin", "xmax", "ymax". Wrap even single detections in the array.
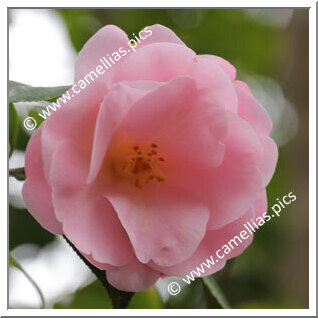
[{"xmin": 50, "ymin": 142, "xmax": 133, "ymax": 266}]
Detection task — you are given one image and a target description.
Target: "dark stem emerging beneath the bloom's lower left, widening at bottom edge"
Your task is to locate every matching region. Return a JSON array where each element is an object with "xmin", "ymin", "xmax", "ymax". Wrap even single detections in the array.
[{"xmin": 63, "ymin": 235, "xmax": 134, "ymax": 309}]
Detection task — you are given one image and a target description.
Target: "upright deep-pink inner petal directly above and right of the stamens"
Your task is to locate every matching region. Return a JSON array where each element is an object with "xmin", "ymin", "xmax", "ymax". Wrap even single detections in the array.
[{"xmin": 121, "ymin": 77, "xmax": 228, "ymax": 166}]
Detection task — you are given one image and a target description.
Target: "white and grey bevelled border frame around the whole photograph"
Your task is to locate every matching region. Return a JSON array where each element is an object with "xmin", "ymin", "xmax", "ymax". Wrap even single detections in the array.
[{"xmin": 0, "ymin": 0, "xmax": 316, "ymax": 316}]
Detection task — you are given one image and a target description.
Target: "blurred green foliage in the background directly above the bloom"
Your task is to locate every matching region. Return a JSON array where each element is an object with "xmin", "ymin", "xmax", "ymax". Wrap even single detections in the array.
[{"xmin": 58, "ymin": 9, "xmax": 284, "ymax": 75}]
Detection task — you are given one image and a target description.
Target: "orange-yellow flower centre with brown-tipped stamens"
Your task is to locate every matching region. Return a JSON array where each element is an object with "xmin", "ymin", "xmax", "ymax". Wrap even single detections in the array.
[{"xmin": 112, "ymin": 143, "xmax": 166, "ymax": 188}]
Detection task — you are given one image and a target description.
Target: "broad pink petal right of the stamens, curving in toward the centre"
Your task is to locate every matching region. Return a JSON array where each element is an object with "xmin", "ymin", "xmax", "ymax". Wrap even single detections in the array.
[{"xmin": 166, "ymin": 113, "xmax": 264, "ymax": 229}]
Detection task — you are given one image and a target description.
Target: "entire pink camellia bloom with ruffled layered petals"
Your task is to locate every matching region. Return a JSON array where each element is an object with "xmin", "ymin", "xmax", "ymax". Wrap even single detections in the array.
[{"xmin": 23, "ymin": 25, "xmax": 277, "ymax": 291}]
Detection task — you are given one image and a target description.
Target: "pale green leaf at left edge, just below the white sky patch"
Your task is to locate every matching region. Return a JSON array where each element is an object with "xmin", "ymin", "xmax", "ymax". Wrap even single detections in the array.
[{"xmin": 9, "ymin": 81, "xmax": 71, "ymax": 103}]
